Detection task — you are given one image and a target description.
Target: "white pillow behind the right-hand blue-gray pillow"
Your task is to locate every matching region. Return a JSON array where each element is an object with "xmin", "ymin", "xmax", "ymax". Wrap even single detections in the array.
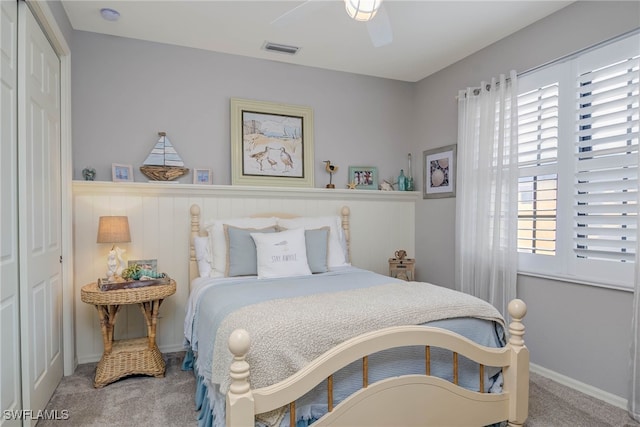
[{"xmin": 278, "ymin": 215, "xmax": 349, "ymax": 268}]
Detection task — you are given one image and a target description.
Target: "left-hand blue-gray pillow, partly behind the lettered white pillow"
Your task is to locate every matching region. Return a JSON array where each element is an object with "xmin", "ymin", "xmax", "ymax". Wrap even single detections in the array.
[{"xmin": 224, "ymin": 224, "xmax": 276, "ymax": 277}]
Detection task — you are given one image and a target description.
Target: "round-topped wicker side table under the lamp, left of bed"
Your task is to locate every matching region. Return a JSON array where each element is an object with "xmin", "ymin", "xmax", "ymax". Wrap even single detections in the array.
[{"xmin": 81, "ymin": 280, "xmax": 176, "ymax": 388}]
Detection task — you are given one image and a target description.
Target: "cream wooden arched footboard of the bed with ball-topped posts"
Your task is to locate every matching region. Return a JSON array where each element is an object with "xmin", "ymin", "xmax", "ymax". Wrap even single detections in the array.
[{"xmin": 226, "ymin": 299, "xmax": 529, "ymax": 427}]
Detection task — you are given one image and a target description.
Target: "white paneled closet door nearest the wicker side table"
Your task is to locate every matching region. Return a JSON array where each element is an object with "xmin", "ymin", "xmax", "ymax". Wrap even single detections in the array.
[{"xmin": 18, "ymin": 2, "xmax": 63, "ymax": 423}]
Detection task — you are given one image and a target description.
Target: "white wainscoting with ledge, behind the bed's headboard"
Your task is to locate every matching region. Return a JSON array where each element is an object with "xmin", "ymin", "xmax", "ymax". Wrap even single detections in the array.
[{"xmin": 73, "ymin": 181, "xmax": 419, "ymax": 363}]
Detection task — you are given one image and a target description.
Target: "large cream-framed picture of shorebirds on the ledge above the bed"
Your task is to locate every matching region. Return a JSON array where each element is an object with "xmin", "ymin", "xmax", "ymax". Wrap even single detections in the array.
[{"xmin": 231, "ymin": 98, "xmax": 314, "ymax": 187}]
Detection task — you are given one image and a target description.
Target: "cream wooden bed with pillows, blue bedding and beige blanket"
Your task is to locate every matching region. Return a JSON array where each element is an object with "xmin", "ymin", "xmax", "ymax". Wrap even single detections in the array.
[{"xmin": 183, "ymin": 205, "xmax": 529, "ymax": 427}]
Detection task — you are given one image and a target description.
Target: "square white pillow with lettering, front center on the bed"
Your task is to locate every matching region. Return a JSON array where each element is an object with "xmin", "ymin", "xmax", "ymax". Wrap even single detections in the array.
[{"xmin": 251, "ymin": 228, "xmax": 311, "ymax": 279}]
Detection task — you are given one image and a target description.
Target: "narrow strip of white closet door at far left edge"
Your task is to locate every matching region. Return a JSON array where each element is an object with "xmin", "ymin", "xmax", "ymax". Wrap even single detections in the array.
[{"xmin": 0, "ymin": 1, "xmax": 22, "ymax": 427}]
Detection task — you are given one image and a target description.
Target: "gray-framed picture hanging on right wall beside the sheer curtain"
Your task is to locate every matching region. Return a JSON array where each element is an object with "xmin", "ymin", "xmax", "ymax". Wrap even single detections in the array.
[{"xmin": 422, "ymin": 144, "xmax": 457, "ymax": 199}]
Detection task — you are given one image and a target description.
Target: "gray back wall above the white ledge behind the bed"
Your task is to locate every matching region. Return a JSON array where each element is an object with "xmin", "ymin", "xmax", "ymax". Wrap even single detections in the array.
[{"xmin": 72, "ymin": 31, "xmax": 413, "ymax": 188}]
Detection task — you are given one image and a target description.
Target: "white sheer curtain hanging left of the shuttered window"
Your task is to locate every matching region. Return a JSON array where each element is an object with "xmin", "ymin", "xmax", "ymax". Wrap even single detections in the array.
[{"xmin": 455, "ymin": 71, "xmax": 518, "ymax": 315}]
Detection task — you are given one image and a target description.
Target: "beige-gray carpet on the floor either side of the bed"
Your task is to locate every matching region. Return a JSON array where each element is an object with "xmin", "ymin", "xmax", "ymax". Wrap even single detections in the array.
[{"xmin": 38, "ymin": 353, "xmax": 640, "ymax": 427}]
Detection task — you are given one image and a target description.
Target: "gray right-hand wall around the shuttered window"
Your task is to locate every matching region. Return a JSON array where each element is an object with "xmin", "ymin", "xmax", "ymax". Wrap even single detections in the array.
[{"xmin": 411, "ymin": 1, "xmax": 640, "ymax": 399}]
